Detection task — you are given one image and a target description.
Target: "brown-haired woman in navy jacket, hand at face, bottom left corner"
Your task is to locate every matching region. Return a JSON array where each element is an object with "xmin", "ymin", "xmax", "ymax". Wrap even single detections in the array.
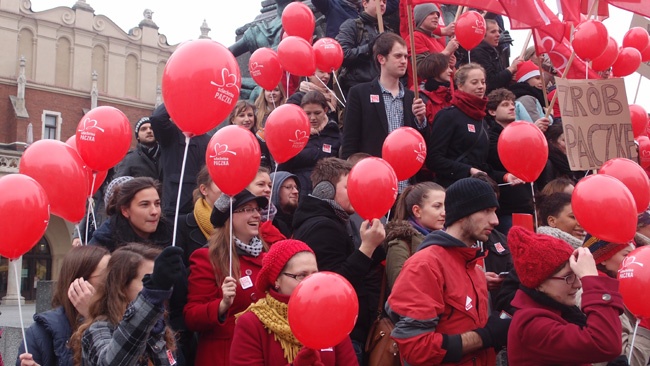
[{"xmin": 16, "ymin": 246, "xmax": 110, "ymax": 366}]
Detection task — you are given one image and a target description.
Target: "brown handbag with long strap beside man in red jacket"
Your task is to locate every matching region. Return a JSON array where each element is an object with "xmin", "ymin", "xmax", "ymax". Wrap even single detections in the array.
[{"xmin": 366, "ymin": 272, "xmax": 401, "ymax": 366}]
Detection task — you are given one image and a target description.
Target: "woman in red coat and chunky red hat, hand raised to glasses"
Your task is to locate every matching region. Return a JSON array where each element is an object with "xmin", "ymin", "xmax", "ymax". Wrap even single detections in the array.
[{"xmin": 508, "ymin": 226, "xmax": 623, "ymax": 366}]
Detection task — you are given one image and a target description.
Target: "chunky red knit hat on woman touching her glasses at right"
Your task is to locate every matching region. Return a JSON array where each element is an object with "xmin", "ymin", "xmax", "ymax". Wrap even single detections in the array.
[{"xmin": 508, "ymin": 226, "xmax": 573, "ymax": 289}]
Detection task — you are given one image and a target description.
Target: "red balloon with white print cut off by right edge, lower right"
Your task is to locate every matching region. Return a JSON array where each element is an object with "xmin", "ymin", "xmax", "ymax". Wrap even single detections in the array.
[{"xmin": 618, "ymin": 246, "xmax": 650, "ymax": 318}]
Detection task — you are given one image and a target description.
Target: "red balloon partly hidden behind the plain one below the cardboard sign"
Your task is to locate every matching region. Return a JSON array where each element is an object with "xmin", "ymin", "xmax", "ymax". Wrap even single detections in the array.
[{"xmin": 598, "ymin": 158, "xmax": 650, "ymax": 213}]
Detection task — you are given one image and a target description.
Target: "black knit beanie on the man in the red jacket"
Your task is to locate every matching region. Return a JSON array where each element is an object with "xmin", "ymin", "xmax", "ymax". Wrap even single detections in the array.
[{"xmin": 445, "ymin": 178, "xmax": 499, "ymax": 227}]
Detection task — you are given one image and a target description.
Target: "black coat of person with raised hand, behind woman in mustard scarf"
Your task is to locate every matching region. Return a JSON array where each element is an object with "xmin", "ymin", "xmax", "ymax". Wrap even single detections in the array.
[{"xmin": 293, "ymin": 196, "xmax": 386, "ymax": 344}]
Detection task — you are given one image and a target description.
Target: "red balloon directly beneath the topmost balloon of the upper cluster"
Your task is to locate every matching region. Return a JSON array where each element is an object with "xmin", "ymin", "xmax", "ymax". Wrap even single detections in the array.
[{"xmin": 278, "ymin": 36, "xmax": 316, "ymax": 76}]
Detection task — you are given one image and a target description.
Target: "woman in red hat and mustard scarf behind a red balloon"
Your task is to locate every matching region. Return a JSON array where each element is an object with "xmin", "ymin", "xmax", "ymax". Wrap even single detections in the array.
[{"xmin": 230, "ymin": 239, "xmax": 358, "ymax": 366}]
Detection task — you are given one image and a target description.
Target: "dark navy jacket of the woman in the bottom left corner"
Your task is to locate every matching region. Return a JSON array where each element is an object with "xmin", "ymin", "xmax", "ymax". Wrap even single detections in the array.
[{"xmin": 16, "ymin": 306, "xmax": 73, "ymax": 366}]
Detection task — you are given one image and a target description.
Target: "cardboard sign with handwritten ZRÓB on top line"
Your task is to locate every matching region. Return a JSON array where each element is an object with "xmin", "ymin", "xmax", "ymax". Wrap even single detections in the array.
[{"xmin": 556, "ymin": 78, "xmax": 638, "ymax": 170}]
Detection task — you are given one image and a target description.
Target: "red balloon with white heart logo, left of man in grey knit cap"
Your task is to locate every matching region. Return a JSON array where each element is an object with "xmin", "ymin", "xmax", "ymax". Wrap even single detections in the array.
[{"xmin": 75, "ymin": 106, "xmax": 133, "ymax": 171}]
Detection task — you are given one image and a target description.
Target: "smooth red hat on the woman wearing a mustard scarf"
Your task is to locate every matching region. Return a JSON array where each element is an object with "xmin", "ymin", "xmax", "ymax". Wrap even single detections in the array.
[{"xmin": 255, "ymin": 239, "xmax": 314, "ymax": 293}]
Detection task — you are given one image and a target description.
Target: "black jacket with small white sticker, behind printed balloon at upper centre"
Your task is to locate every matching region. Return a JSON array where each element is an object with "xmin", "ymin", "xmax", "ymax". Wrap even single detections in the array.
[{"xmin": 278, "ymin": 121, "xmax": 341, "ymax": 196}]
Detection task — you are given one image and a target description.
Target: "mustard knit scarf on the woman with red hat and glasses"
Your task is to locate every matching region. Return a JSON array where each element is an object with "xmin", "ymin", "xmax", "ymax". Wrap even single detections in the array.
[{"xmin": 235, "ymin": 292, "xmax": 302, "ymax": 363}]
